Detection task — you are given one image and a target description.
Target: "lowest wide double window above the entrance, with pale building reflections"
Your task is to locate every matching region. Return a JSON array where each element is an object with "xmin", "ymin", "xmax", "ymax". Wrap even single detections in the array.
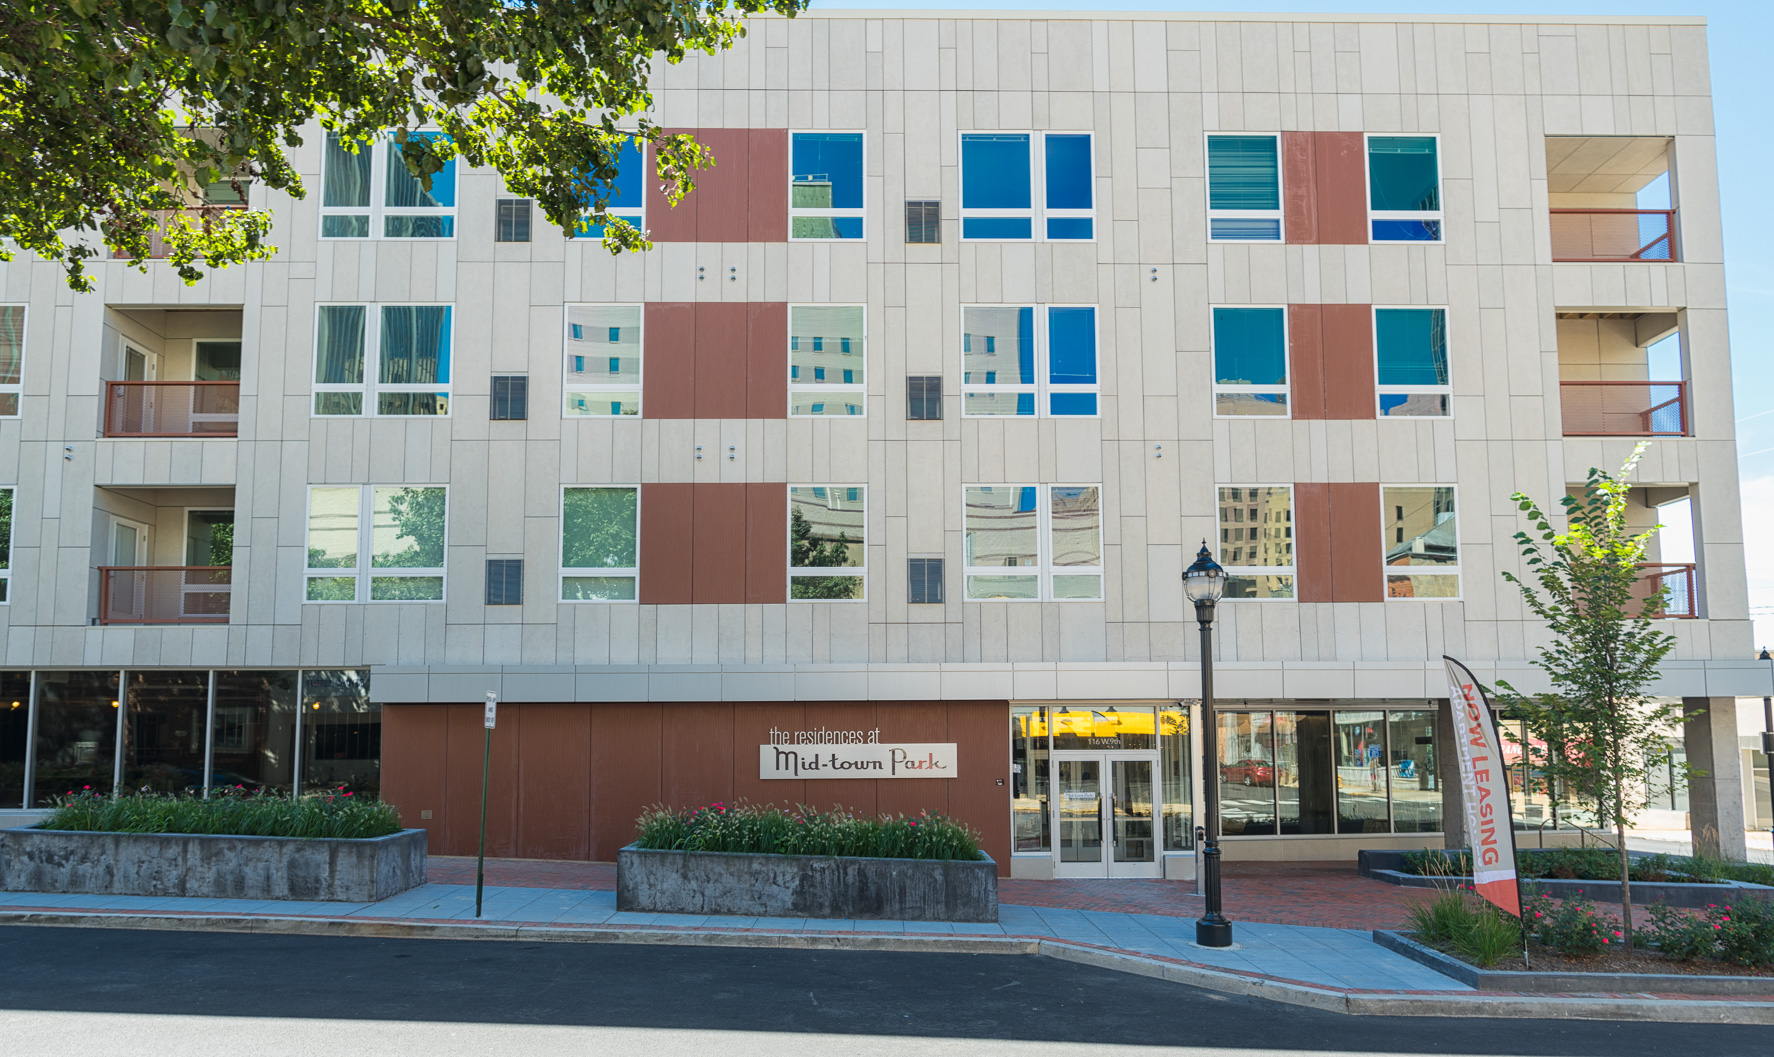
[{"xmin": 963, "ymin": 484, "xmax": 1103, "ymax": 601}]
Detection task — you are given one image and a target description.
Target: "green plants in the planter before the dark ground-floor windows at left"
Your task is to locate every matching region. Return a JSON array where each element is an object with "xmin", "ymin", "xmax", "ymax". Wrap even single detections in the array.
[{"xmin": 37, "ymin": 786, "xmax": 401, "ymax": 839}]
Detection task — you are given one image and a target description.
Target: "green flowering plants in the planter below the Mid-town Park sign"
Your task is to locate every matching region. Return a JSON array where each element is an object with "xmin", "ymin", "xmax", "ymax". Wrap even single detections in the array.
[{"xmin": 635, "ymin": 802, "xmax": 979, "ymax": 862}]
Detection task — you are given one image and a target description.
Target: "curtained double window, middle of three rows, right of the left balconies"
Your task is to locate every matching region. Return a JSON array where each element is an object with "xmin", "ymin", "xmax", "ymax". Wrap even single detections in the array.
[{"xmin": 314, "ymin": 305, "xmax": 451, "ymax": 415}]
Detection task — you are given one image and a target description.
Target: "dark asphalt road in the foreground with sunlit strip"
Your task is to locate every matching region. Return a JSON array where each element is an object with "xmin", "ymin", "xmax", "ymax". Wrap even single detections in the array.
[{"xmin": 0, "ymin": 926, "xmax": 1770, "ymax": 1057}]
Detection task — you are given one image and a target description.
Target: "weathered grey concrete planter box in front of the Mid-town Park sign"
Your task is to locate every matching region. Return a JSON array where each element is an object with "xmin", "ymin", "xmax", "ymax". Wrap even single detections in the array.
[{"xmin": 616, "ymin": 844, "xmax": 997, "ymax": 920}]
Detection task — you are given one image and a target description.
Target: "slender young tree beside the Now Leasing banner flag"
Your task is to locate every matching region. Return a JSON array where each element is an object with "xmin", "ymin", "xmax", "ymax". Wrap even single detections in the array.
[{"xmin": 1497, "ymin": 443, "xmax": 1684, "ymax": 951}]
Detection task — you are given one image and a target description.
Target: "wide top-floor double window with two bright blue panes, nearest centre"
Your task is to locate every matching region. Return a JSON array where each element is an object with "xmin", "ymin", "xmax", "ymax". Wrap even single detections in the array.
[{"xmin": 962, "ymin": 131, "xmax": 1096, "ymax": 241}]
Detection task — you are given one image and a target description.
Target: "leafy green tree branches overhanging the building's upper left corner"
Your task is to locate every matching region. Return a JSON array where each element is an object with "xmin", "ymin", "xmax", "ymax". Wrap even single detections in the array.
[{"xmin": 0, "ymin": 0, "xmax": 807, "ymax": 291}]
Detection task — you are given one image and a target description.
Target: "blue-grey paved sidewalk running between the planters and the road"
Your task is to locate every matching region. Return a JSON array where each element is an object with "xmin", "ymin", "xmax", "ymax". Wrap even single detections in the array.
[{"xmin": 0, "ymin": 883, "xmax": 1774, "ymax": 1023}]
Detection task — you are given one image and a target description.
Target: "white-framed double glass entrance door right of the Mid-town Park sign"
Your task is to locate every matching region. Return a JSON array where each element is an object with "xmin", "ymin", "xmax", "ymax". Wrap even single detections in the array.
[{"xmin": 1054, "ymin": 754, "xmax": 1162, "ymax": 878}]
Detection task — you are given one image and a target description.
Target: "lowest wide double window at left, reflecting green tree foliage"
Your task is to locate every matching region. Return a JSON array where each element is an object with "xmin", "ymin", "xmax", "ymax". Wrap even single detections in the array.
[{"xmin": 307, "ymin": 484, "xmax": 449, "ymax": 601}]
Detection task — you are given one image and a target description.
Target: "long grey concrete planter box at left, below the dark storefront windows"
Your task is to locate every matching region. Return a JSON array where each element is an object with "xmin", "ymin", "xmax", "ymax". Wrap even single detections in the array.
[{"xmin": 0, "ymin": 828, "xmax": 426, "ymax": 903}]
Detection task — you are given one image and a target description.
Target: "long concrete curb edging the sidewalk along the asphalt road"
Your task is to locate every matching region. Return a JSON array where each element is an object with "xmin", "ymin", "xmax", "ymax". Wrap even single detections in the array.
[{"xmin": 10, "ymin": 910, "xmax": 1774, "ymax": 1025}]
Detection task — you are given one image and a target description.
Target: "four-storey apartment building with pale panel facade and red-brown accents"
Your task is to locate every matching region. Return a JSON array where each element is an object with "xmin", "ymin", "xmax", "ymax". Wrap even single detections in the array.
[{"xmin": 0, "ymin": 12, "xmax": 1769, "ymax": 876}]
